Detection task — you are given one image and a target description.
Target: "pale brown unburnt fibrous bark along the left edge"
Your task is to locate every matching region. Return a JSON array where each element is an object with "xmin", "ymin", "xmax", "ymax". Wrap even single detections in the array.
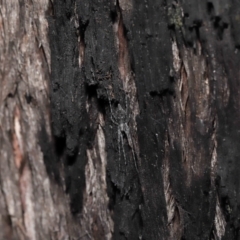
[{"xmin": 0, "ymin": 0, "xmax": 83, "ymax": 240}]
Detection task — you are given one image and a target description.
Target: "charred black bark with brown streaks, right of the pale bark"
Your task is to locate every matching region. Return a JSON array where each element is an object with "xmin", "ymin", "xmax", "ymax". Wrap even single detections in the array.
[{"xmin": 47, "ymin": 1, "xmax": 240, "ymax": 239}]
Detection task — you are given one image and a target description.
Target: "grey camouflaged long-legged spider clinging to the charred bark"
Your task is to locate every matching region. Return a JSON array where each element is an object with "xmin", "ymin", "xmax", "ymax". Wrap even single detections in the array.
[{"xmin": 107, "ymin": 92, "xmax": 138, "ymax": 171}]
